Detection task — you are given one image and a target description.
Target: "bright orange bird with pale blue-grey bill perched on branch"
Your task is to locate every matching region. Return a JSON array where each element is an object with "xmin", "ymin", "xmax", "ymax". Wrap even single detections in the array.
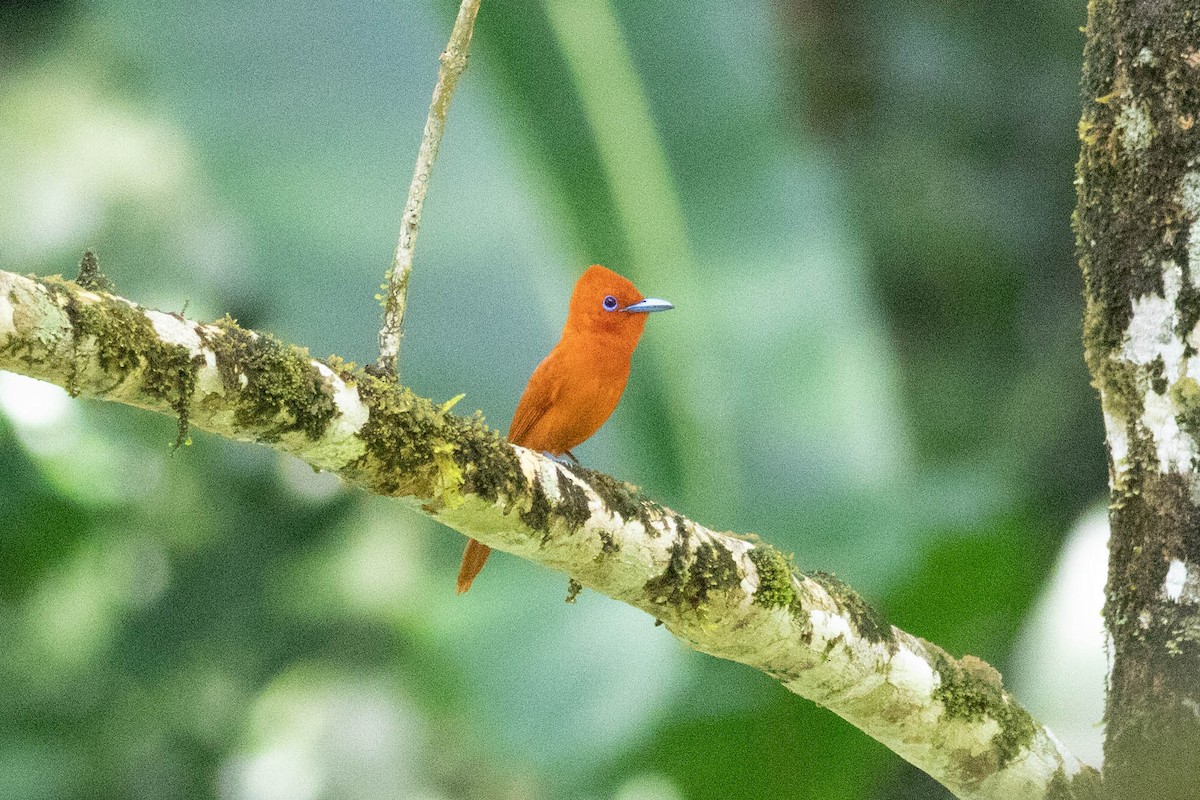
[{"xmin": 458, "ymin": 264, "xmax": 673, "ymax": 594}]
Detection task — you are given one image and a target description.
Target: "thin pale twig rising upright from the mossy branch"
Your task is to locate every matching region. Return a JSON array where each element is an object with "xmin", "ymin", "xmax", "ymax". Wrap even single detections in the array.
[{"xmin": 378, "ymin": 0, "xmax": 480, "ymax": 378}]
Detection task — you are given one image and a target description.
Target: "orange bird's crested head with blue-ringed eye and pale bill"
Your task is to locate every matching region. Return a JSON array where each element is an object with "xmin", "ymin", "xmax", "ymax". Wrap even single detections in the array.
[{"xmin": 566, "ymin": 264, "xmax": 673, "ymax": 345}]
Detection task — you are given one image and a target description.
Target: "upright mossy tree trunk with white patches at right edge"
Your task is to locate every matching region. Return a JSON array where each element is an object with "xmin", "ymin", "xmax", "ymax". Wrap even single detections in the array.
[{"xmin": 1075, "ymin": 0, "xmax": 1200, "ymax": 800}]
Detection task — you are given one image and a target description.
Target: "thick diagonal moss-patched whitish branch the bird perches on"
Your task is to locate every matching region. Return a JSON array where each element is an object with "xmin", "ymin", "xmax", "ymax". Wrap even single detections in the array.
[{"xmin": 0, "ymin": 271, "xmax": 1098, "ymax": 800}]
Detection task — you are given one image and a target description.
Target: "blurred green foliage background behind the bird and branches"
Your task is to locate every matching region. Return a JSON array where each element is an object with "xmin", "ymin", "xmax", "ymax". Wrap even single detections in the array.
[{"xmin": 0, "ymin": 0, "xmax": 1106, "ymax": 800}]
